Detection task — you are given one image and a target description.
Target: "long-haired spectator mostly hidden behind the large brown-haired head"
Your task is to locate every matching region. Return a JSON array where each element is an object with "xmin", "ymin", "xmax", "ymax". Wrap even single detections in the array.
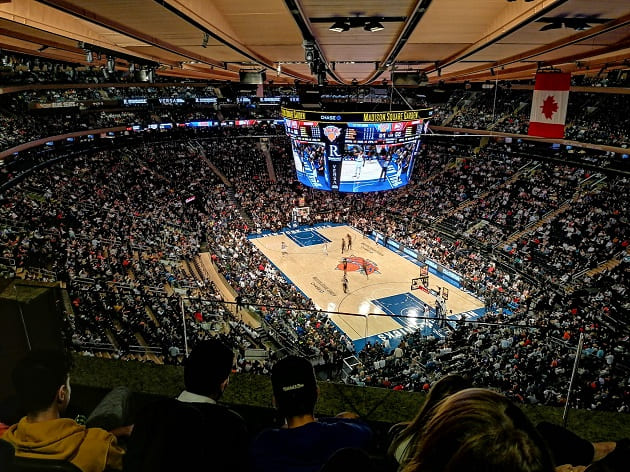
[{"xmin": 387, "ymin": 374, "xmax": 471, "ymax": 469}]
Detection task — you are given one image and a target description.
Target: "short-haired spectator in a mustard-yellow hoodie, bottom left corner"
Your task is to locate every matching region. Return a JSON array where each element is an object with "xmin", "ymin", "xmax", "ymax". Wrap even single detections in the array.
[{"xmin": 2, "ymin": 350, "xmax": 124, "ymax": 472}]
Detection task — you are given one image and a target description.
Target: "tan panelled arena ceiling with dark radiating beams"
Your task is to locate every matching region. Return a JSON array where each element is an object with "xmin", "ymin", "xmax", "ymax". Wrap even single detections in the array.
[{"xmin": 0, "ymin": 0, "xmax": 630, "ymax": 84}]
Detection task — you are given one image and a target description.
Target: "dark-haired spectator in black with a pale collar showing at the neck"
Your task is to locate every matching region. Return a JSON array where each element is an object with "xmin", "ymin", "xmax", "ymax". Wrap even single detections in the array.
[{"xmin": 124, "ymin": 339, "xmax": 248, "ymax": 472}]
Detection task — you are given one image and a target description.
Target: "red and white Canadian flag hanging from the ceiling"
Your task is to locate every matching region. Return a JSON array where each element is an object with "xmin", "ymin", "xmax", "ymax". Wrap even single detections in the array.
[{"xmin": 527, "ymin": 72, "xmax": 571, "ymax": 138}]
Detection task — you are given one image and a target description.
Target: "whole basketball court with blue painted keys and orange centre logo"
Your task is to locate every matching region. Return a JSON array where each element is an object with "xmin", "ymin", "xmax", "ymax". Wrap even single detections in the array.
[{"xmin": 250, "ymin": 224, "xmax": 485, "ymax": 350}]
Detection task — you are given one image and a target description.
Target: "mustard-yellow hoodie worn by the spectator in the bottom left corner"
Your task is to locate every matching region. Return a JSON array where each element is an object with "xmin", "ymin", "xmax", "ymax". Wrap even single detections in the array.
[{"xmin": 2, "ymin": 417, "xmax": 124, "ymax": 472}]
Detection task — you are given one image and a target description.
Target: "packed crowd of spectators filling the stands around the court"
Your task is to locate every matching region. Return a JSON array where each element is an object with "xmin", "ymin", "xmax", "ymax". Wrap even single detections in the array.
[{"xmin": 0, "ymin": 76, "xmax": 630, "ymax": 411}]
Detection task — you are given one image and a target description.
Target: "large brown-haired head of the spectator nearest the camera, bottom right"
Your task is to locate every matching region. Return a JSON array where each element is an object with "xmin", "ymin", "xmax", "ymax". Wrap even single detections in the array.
[{"xmin": 404, "ymin": 388, "xmax": 554, "ymax": 472}]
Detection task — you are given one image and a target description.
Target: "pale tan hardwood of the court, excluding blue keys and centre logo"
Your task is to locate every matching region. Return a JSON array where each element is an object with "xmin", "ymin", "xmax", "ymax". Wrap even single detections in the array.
[{"xmin": 251, "ymin": 226, "xmax": 483, "ymax": 341}]
